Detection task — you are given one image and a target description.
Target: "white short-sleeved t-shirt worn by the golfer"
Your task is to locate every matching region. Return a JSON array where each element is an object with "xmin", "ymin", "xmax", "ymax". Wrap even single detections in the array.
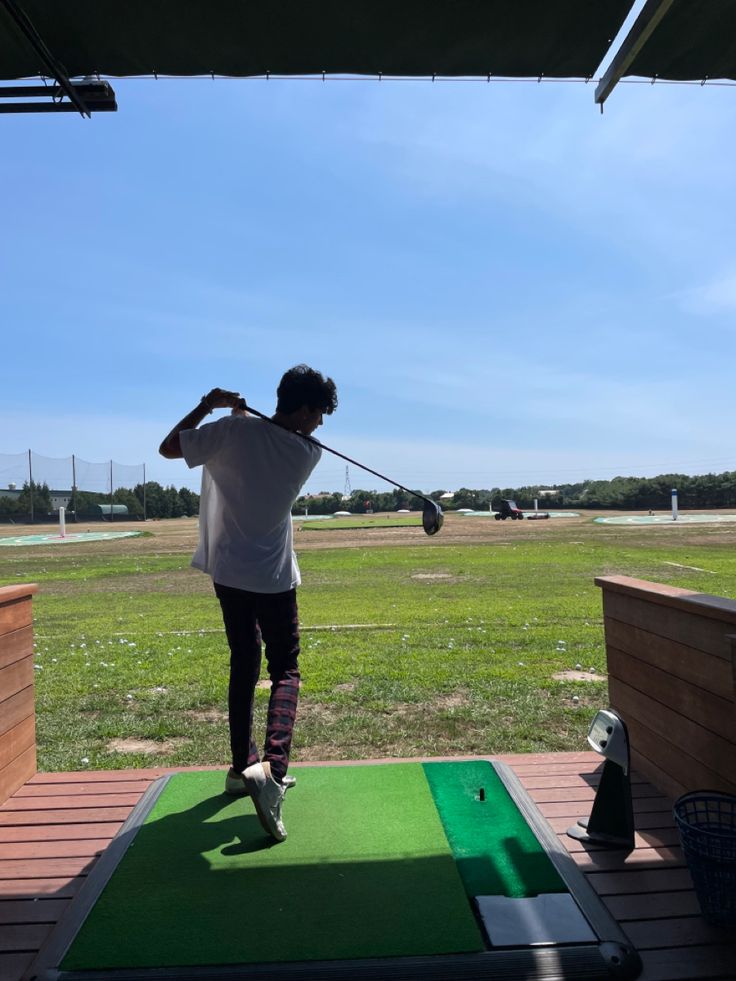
[{"xmin": 179, "ymin": 416, "xmax": 322, "ymax": 593}]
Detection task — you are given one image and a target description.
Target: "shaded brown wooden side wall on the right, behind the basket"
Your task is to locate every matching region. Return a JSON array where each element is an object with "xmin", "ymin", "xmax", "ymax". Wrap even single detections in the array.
[{"xmin": 596, "ymin": 576, "xmax": 736, "ymax": 798}]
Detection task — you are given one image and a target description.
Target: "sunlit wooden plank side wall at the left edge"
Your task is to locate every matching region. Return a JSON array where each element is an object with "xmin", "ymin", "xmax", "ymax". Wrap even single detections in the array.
[{"xmin": 0, "ymin": 586, "xmax": 38, "ymax": 803}]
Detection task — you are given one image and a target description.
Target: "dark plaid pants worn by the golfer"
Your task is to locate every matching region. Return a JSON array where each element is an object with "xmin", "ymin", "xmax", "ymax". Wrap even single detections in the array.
[{"xmin": 215, "ymin": 583, "xmax": 300, "ymax": 780}]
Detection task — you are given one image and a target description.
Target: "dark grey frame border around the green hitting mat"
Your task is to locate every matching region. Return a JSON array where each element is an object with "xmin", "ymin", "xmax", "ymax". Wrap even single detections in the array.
[{"xmin": 23, "ymin": 757, "xmax": 642, "ymax": 981}]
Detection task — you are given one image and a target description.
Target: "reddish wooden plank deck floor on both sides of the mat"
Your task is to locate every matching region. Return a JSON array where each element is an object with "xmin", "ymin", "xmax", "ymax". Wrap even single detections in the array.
[{"xmin": 0, "ymin": 753, "xmax": 736, "ymax": 981}]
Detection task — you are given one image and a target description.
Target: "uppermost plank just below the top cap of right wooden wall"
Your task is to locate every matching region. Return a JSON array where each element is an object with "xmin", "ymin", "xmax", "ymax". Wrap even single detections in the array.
[{"xmin": 603, "ymin": 593, "xmax": 733, "ymax": 663}]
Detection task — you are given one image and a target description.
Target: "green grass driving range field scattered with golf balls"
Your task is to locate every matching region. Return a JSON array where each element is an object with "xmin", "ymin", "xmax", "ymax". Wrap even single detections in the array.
[{"xmin": 0, "ymin": 516, "xmax": 736, "ymax": 770}]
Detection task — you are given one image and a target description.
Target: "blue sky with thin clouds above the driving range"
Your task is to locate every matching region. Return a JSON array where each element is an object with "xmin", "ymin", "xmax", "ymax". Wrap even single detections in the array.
[{"xmin": 0, "ymin": 33, "xmax": 736, "ymax": 492}]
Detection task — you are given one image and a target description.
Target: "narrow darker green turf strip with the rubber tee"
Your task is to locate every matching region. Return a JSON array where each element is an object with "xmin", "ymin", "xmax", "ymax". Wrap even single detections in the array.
[{"xmin": 424, "ymin": 760, "xmax": 567, "ymax": 897}]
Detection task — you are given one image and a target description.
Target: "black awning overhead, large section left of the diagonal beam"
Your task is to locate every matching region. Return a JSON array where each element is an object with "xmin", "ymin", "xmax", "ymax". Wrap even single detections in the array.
[{"xmin": 0, "ymin": 0, "xmax": 632, "ymax": 80}]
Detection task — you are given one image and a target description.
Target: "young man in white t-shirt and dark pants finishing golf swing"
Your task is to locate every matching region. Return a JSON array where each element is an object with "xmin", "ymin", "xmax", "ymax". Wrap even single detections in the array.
[{"xmin": 159, "ymin": 364, "xmax": 337, "ymax": 841}]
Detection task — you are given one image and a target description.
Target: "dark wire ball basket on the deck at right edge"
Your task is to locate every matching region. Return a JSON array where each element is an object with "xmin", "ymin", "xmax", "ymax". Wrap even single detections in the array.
[{"xmin": 675, "ymin": 790, "xmax": 736, "ymax": 926}]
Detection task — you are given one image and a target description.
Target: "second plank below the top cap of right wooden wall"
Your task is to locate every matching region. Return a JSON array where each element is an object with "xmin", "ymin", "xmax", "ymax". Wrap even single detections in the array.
[{"xmin": 605, "ymin": 617, "xmax": 733, "ymax": 695}]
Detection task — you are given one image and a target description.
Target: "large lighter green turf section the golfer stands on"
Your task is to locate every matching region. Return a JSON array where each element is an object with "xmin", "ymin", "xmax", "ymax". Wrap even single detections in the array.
[{"xmin": 61, "ymin": 763, "xmax": 485, "ymax": 970}]
